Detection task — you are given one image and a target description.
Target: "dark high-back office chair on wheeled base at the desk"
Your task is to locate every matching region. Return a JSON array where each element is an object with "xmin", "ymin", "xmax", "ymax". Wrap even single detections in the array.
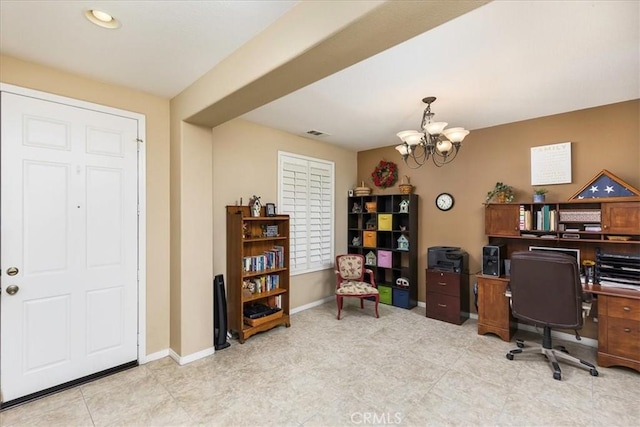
[{"xmin": 507, "ymin": 251, "xmax": 598, "ymax": 380}]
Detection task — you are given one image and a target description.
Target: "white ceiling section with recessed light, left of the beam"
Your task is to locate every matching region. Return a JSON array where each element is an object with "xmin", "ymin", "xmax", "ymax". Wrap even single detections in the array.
[{"xmin": 0, "ymin": 0, "xmax": 297, "ymax": 98}]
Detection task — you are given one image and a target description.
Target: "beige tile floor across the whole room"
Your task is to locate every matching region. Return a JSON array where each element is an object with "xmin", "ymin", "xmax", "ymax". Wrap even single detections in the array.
[{"xmin": 0, "ymin": 301, "xmax": 640, "ymax": 427}]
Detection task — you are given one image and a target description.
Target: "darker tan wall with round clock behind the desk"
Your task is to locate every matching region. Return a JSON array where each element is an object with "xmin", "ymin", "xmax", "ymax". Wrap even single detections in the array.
[{"xmin": 358, "ymin": 100, "xmax": 640, "ymax": 310}]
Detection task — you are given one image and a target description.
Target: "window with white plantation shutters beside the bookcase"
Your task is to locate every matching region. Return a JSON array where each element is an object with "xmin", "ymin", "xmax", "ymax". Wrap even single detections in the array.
[{"xmin": 278, "ymin": 151, "xmax": 335, "ymax": 274}]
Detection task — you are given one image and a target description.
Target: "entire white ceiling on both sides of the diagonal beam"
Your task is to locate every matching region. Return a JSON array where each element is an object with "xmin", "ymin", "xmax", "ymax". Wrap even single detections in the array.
[{"xmin": 0, "ymin": 0, "xmax": 640, "ymax": 150}]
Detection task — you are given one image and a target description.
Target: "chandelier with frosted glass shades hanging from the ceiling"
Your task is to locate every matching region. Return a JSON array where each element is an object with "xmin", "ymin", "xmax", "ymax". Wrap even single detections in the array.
[{"xmin": 396, "ymin": 96, "xmax": 469, "ymax": 169}]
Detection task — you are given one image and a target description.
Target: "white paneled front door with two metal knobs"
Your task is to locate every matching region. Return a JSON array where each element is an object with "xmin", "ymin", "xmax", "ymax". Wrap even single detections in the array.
[{"xmin": 0, "ymin": 92, "xmax": 138, "ymax": 402}]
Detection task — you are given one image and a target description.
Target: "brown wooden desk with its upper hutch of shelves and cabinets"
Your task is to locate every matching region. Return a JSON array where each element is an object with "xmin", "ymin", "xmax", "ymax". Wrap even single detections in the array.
[{"xmin": 477, "ymin": 199, "xmax": 640, "ymax": 372}]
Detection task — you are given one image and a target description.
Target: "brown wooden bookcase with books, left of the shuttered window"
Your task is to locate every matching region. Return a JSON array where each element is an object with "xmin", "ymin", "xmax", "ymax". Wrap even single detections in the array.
[{"xmin": 226, "ymin": 206, "xmax": 291, "ymax": 343}]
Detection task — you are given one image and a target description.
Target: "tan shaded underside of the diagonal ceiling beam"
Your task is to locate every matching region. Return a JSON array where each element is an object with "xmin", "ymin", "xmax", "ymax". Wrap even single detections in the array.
[{"xmin": 185, "ymin": 0, "xmax": 489, "ymax": 127}]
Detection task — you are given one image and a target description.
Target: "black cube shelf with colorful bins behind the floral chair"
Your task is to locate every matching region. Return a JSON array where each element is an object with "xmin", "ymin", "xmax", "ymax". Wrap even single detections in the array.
[{"xmin": 347, "ymin": 194, "xmax": 418, "ymax": 309}]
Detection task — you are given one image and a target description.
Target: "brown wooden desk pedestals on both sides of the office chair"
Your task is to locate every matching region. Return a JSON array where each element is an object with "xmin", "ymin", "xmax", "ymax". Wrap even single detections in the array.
[{"xmin": 476, "ymin": 274, "xmax": 640, "ymax": 372}]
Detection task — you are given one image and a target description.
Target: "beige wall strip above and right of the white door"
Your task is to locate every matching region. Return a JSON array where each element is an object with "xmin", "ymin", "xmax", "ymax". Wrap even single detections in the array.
[{"xmin": 0, "ymin": 56, "xmax": 169, "ymax": 354}]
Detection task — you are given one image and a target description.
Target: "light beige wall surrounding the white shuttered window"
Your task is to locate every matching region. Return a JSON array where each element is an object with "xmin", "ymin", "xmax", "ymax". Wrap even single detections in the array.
[{"xmin": 213, "ymin": 119, "xmax": 356, "ymax": 309}]
